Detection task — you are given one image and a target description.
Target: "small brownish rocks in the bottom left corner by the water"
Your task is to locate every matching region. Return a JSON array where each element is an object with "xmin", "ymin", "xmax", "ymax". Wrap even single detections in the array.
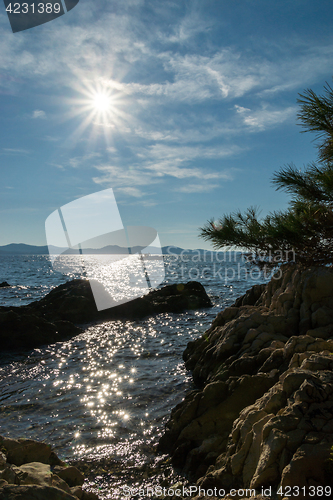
[{"xmin": 0, "ymin": 436, "xmax": 98, "ymax": 500}]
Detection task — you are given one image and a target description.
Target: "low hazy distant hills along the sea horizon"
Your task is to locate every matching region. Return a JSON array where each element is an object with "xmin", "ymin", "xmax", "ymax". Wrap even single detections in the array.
[{"xmin": 0, "ymin": 243, "xmax": 215, "ymax": 256}]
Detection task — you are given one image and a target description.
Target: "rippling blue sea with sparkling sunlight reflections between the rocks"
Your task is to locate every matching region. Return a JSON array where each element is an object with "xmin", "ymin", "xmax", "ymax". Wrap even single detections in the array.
[{"xmin": 0, "ymin": 252, "xmax": 270, "ymax": 499}]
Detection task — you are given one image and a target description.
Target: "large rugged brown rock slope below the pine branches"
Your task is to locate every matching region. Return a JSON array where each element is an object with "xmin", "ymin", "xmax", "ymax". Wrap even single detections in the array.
[{"xmin": 159, "ymin": 266, "xmax": 333, "ymax": 500}]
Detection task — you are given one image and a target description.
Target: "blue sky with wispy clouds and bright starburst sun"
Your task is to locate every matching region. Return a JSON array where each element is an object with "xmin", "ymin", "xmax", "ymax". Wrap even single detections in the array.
[{"xmin": 0, "ymin": 0, "xmax": 333, "ymax": 248}]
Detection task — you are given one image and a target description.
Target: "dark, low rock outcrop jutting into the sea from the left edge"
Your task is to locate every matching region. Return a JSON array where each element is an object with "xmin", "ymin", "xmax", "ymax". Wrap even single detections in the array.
[{"xmin": 0, "ymin": 280, "xmax": 212, "ymax": 350}]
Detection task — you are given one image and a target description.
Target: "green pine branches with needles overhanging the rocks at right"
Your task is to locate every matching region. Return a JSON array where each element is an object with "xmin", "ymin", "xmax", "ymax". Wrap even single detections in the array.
[{"xmin": 200, "ymin": 80, "xmax": 333, "ymax": 266}]
